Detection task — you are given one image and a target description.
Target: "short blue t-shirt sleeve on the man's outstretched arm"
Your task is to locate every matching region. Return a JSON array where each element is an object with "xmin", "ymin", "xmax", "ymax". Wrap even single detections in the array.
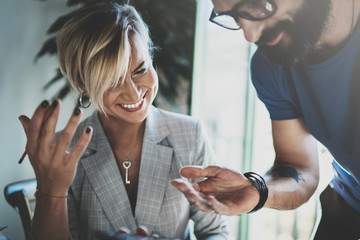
[{"xmin": 251, "ymin": 50, "xmax": 301, "ymax": 120}]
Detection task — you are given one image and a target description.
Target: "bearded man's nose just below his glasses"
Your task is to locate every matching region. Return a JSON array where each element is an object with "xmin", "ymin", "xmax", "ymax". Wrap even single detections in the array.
[{"xmin": 238, "ymin": 17, "xmax": 265, "ymax": 43}]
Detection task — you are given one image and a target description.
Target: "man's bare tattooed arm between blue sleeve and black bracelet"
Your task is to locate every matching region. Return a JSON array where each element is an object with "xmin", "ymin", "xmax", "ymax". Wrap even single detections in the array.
[{"xmin": 264, "ymin": 118, "xmax": 319, "ymax": 209}]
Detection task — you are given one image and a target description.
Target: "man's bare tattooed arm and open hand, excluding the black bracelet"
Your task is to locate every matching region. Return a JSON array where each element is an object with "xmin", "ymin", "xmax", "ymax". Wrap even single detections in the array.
[{"xmin": 172, "ymin": 119, "xmax": 319, "ymax": 215}]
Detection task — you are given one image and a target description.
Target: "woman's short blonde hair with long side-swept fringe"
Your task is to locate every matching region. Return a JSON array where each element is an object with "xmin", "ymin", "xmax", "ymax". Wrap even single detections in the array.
[{"xmin": 57, "ymin": 2, "xmax": 153, "ymax": 111}]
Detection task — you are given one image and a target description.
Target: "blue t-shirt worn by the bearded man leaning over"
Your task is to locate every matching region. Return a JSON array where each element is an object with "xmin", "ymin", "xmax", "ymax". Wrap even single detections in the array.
[{"xmin": 251, "ymin": 21, "xmax": 360, "ymax": 211}]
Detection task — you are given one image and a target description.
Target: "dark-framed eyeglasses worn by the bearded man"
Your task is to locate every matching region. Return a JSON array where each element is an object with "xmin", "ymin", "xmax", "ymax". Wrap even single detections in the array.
[{"xmin": 209, "ymin": 0, "xmax": 277, "ymax": 30}]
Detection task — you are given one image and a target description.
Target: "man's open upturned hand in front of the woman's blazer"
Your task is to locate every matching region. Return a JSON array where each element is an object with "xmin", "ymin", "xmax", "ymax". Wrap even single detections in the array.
[{"xmin": 172, "ymin": 166, "xmax": 260, "ymax": 215}]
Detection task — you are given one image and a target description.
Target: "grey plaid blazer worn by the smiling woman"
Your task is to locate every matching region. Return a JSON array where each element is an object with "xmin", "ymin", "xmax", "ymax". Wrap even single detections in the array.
[{"xmin": 68, "ymin": 107, "xmax": 227, "ymax": 240}]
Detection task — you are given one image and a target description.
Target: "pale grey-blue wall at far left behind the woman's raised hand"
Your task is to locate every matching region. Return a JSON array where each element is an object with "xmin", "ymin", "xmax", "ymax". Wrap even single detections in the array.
[{"xmin": 0, "ymin": 0, "xmax": 91, "ymax": 240}]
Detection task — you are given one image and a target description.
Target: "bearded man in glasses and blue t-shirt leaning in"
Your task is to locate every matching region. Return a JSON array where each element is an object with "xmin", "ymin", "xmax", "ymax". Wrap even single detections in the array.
[{"xmin": 173, "ymin": 0, "xmax": 360, "ymax": 239}]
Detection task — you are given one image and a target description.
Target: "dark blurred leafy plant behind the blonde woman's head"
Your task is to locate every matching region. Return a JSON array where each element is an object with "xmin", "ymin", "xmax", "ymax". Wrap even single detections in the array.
[{"xmin": 34, "ymin": 0, "xmax": 196, "ymax": 114}]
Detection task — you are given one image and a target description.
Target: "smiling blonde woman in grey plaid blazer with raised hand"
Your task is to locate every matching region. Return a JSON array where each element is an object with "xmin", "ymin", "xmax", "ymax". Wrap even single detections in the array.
[{"xmin": 20, "ymin": 3, "xmax": 227, "ymax": 240}]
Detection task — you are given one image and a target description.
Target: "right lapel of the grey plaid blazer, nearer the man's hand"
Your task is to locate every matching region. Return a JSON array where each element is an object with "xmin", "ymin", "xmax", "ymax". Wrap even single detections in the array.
[{"xmin": 135, "ymin": 107, "xmax": 173, "ymax": 232}]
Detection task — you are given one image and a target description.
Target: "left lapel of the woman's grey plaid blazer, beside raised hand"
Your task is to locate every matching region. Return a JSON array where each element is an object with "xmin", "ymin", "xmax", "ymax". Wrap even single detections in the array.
[{"xmin": 81, "ymin": 113, "xmax": 136, "ymax": 230}]
